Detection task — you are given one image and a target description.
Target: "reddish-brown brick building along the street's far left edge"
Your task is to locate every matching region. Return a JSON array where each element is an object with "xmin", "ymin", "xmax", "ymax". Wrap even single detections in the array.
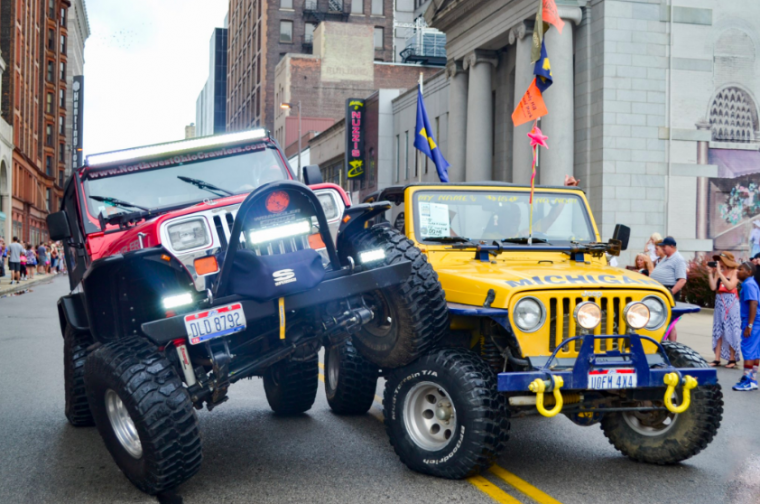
[{"xmin": 0, "ymin": 0, "xmax": 70, "ymax": 243}]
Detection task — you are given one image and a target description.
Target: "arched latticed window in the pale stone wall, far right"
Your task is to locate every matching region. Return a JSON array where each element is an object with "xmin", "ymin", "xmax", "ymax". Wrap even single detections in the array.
[{"xmin": 710, "ymin": 86, "xmax": 760, "ymax": 143}]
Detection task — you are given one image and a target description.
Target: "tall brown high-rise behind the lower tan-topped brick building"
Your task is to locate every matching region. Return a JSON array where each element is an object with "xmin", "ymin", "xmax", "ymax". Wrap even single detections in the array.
[{"xmin": 227, "ymin": 0, "xmax": 394, "ymax": 136}]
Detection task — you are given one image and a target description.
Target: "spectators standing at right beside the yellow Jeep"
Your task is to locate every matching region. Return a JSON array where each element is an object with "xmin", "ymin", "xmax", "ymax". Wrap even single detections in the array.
[{"xmin": 629, "ymin": 232, "xmax": 760, "ymax": 391}]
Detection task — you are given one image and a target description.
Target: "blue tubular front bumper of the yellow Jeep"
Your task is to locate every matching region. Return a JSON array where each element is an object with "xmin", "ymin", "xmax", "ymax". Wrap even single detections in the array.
[{"xmin": 498, "ymin": 334, "xmax": 718, "ymax": 392}]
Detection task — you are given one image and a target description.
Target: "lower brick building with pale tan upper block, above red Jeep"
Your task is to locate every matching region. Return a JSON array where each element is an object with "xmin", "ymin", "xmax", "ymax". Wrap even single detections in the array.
[{"xmin": 274, "ymin": 22, "xmax": 440, "ymax": 147}]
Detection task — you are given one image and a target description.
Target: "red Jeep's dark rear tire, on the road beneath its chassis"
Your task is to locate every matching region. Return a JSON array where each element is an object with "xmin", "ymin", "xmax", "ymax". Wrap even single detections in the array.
[{"xmin": 264, "ymin": 354, "xmax": 319, "ymax": 415}]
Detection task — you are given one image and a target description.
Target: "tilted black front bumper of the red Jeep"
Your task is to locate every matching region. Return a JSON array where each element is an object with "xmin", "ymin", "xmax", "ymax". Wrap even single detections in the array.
[{"xmin": 142, "ymin": 261, "xmax": 412, "ymax": 346}]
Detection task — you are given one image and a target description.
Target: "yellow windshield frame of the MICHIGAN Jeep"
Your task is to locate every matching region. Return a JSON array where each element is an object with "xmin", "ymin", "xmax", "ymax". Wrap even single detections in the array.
[{"xmin": 404, "ymin": 184, "xmax": 599, "ymax": 246}]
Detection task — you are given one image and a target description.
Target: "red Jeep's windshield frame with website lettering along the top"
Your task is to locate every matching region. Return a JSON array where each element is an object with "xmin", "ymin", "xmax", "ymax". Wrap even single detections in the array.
[{"xmin": 75, "ymin": 139, "xmax": 294, "ymax": 235}]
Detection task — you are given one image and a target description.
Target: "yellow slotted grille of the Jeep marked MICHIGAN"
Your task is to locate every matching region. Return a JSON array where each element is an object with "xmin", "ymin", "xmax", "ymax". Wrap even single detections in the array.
[{"xmin": 548, "ymin": 295, "xmax": 633, "ymax": 356}]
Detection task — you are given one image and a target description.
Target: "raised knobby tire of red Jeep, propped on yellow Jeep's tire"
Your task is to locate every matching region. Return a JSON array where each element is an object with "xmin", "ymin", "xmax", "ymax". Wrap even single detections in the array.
[{"xmin": 342, "ymin": 226, "xmax": 449, "ymax": 369}]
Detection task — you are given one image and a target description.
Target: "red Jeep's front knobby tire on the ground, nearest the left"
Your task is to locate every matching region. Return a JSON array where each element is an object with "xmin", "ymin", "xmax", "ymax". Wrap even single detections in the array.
[{"xmin": 85, "ymin": 337, "xmax": 203, "ymax": 495}]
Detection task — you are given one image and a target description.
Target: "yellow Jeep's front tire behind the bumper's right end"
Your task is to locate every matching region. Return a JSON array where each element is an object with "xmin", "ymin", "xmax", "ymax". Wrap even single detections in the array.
[{"xmin": 602, "ymin": 342, "xmax": 723, "ymax": 465}]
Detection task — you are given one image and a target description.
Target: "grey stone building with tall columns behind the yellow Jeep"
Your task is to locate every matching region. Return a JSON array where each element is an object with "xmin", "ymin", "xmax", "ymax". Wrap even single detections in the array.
[{"xmin": 385, "ymin": 0, "xmax": 760, "ymax": 264}]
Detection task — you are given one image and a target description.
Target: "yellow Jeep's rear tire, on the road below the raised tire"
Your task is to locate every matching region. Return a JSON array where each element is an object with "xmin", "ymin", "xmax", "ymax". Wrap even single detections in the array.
[{"xmin": 325, "ymin": 340, "xmax": 379, "ymax": 415}]
